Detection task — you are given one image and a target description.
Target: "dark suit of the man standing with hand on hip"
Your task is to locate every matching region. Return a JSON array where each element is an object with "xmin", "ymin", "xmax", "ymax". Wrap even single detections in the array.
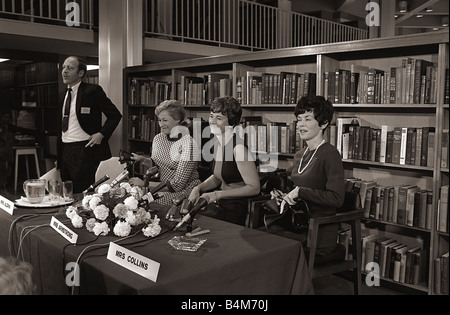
[{"xmin": 57, "ymin": 82, "xmax": 122, "ymax": 192}]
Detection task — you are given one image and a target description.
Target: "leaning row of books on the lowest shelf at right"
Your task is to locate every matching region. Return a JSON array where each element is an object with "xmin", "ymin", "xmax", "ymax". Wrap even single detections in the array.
[{"xmin": 361, "ymin": 234, "xmax": 428, "ymax": 285}]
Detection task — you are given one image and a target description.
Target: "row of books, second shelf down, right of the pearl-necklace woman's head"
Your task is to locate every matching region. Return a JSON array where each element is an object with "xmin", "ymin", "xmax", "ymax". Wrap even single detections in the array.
[{"xmin": 330, "ymin": 116, "xmax": 449, "ymax": 168}]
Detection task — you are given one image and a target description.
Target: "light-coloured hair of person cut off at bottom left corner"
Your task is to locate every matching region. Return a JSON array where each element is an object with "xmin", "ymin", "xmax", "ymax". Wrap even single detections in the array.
[{"xmin": 0, "ymin": 257, "xmax": 34, "ymax": 295}]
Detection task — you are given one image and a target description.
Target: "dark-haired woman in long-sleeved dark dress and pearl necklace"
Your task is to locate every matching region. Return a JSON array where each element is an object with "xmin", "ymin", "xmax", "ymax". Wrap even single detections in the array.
[{"xmin": 281, "ymin": 95, "xmax": 345, "ymax": 255}]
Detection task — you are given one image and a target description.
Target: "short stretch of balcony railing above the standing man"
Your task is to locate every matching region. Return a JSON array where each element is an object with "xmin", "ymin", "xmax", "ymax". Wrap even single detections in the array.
[{"xmin": 0, "ymin": 0, "xmax": 94, "ymax": 30}]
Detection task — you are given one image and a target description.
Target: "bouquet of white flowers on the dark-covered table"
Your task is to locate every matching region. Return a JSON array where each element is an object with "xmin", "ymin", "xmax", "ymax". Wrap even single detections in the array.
[{"xmin": 66, "ymin": 183, "xmax": 161, "ymax": 237}]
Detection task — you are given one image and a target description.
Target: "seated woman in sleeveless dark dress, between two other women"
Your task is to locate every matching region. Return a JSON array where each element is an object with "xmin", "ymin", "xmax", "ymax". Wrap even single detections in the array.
[{"xmin": 189, "ymin": 97, "xmax": 260, "ymax": 225}]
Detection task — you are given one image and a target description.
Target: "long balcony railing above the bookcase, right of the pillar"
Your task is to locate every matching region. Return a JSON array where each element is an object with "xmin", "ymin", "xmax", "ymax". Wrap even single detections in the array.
[{"xmin": 145, "ymin": 0, "xmax": 368, "ymax": 50}]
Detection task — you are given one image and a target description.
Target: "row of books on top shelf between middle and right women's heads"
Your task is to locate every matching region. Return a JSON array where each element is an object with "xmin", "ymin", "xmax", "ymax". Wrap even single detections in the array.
[{"xmin": 236, "ymin": 71, "xmax": 316, "ymax": 105}]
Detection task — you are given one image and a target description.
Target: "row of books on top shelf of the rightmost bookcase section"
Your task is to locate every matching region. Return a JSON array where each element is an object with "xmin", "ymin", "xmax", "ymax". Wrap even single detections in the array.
[{"xmin": 323, "ymin": 58, "xmax": 437, "ymax": 104}]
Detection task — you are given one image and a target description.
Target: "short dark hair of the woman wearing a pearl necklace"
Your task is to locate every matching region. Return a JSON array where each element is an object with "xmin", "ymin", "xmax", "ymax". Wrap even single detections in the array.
[{"xmin": 294, "ymin": 95, "xmax": 334, "ymax": 131}]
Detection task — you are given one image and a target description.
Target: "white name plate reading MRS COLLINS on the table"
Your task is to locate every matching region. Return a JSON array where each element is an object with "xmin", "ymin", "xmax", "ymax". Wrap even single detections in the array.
[{"xmin": 107, "ymin": 242, "xmax": 160, "ymax": 282}]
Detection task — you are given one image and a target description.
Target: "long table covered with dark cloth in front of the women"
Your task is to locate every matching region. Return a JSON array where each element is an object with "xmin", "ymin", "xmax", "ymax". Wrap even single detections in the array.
[{"xmin": 0, "ymin": 199, "xmax": 314, "ymax": 295}]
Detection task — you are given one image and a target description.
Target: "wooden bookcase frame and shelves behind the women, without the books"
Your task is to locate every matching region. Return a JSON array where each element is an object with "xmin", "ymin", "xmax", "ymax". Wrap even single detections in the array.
[{"xmin": 123, "ymin": 30, "xmax": 449, "ymax": 294}]
